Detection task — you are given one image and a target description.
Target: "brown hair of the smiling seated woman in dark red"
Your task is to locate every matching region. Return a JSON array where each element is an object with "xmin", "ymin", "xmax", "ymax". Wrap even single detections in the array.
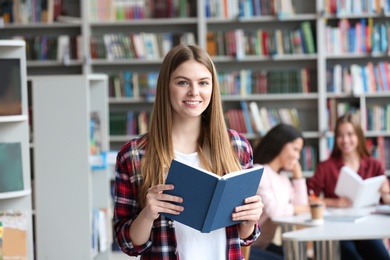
[{"xmin": 331, "ymin": 112, "xmax": 371, "ymax": 158}]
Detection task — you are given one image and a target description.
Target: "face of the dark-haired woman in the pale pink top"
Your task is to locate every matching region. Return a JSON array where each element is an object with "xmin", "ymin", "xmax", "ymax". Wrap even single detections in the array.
[{"xmin": 279, "ymin": 138, "xmax": 303, "ymax": 170}]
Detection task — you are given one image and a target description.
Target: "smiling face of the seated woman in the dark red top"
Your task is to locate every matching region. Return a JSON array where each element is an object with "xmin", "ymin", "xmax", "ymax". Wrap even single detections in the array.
[{"xmin": 336, "ymin": 122, "xmax": 359, "ymax": 155}]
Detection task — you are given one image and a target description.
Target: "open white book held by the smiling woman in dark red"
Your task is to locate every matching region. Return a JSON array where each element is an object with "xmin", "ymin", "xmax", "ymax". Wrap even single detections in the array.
[{"xmin": 335, "ymin": 166, "xmax": 386, "ymax": 208}]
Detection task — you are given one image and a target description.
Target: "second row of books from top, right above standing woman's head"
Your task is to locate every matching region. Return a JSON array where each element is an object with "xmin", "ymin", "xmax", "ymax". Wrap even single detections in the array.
[{"xmin": 206, "ymin": 22, "xmax": 316, "ymax": 59}]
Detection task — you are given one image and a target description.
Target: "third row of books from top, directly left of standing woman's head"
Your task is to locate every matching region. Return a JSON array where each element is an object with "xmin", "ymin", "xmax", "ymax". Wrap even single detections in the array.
[{"xmin": 108, "ymin": 70, "xmax": 158, "ymax": 100}]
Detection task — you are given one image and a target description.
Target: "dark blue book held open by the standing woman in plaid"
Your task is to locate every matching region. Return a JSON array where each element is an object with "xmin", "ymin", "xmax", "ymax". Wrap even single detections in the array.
[{"xmin": 162, "ymin": 160, "xmax": 264, "ymax": 233}]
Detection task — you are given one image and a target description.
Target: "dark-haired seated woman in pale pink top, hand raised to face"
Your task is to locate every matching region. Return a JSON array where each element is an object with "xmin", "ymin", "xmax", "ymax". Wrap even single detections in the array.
[{"xmin": 251, "ymin": 124, "xmax": 310, "ymax": 255}]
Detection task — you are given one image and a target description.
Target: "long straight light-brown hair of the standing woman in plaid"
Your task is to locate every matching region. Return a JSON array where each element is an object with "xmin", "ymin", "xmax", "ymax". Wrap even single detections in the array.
[{"xmin": 139, "ymin": 45, "xmax": 241, "ymax": 207}]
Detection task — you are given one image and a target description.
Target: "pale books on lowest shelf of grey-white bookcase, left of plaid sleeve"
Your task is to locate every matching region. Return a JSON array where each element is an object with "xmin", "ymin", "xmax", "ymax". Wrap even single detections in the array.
[{"xmin": 91, "ymin": 208, "xmax": 112, "ymax": 255}]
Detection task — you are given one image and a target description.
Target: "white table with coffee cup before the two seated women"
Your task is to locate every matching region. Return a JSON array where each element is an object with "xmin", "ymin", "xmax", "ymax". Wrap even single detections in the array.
[{"xmin": 272, "ymin": 209, "xmax": 390, "ymax": 260}]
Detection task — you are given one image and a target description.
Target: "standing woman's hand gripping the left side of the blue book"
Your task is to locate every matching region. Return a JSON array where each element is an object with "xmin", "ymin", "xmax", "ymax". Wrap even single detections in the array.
[{"xmin": 142, "ymin": 184, "xmax": 184, "ymax": 221}]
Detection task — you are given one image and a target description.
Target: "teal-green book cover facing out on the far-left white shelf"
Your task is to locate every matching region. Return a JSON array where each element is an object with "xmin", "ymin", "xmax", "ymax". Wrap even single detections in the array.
[{"xmin": 0, "ymin": 143, "xmax": 23, "ymax": 192}]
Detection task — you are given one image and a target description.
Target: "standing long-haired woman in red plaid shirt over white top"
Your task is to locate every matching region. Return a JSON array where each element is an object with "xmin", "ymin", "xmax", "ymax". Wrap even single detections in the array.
[{"xmin": 113, "ymin": 45, "xmax": 264, "ymax": 260}]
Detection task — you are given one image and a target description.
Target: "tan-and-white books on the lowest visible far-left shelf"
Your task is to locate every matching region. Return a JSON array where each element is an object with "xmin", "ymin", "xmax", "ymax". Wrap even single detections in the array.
[{"xmin": 0, "ymin": 210, "xmax": 28, "ymax": 259}]
